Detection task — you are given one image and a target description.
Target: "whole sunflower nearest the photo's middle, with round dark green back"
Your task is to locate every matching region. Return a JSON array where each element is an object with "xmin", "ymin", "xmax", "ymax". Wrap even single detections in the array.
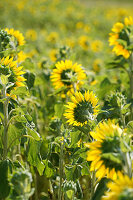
[{"xmin": 64, "ymin": 90, "xmax": 99, "ymax": 127}]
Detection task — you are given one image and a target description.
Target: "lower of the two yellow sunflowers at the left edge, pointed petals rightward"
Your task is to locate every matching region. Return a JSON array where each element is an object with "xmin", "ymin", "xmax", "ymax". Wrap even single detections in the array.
[{"xmin": 0, "ymin": 56, "xmax": 26, "ymax": 94}]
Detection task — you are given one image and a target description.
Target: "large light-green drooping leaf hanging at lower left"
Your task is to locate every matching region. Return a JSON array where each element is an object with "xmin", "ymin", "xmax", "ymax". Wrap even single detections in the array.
[{"xmin": 28, "ymin": 140, "xmax": 45, "ymax": 176}]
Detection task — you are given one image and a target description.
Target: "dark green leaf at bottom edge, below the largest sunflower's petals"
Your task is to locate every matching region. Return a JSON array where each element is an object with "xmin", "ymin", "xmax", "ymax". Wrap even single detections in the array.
[{"xmin": 92, "ymin": 178, "xmax": 109, "ymax": 200}]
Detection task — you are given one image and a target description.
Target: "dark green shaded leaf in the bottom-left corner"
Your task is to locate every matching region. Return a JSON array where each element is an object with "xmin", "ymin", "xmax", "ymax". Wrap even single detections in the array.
[{"xmin": 0, "ymin": 160, "xmax": 10, "ymax": 199}]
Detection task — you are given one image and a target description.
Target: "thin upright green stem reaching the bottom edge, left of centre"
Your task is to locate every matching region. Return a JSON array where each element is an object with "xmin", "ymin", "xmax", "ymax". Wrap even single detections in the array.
[{"xmin": 59, "ymin": 141, "xmax": 64, "ymax": 200}]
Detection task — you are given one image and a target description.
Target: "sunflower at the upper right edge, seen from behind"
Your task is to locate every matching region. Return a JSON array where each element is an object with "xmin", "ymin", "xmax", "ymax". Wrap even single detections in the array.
[{"xmin": 109, "ymin": 16, "xmax": 133, "ymax": 59}]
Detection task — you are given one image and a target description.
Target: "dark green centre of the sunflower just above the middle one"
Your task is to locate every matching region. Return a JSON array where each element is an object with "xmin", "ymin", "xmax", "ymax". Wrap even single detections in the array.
[{"xmin": 61, "ymin": 69, "xmax": 76, "ymax": 86}]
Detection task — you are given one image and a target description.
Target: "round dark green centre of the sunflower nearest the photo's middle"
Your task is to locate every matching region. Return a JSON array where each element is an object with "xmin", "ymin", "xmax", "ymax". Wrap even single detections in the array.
[{"xmin": 74, "ymin": 101, "xmax": 94, "ymax": 123}]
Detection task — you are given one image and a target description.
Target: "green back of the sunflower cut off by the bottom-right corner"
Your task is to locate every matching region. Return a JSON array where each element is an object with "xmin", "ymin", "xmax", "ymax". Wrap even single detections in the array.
[{"xmin": 119, "ymin": 188, "xmax": 133, "ymax": 200}]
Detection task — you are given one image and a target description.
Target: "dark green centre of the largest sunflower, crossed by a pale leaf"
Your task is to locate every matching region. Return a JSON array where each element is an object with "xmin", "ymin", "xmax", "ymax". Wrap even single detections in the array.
[{"xmin": 101, "ymin": 136, "xmax": 122, "ymax": 171}]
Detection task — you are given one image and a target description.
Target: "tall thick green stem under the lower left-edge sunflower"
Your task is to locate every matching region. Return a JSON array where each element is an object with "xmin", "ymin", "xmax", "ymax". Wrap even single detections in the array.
[{"xmin": 3, "ymin": 85, "xmax": 8, "ymax": 160}]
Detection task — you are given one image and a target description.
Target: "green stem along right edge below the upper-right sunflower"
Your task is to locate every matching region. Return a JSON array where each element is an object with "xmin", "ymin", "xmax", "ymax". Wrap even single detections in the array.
[{"xmin": 129, "ymin": 54, "xmax": 133, "ymax": 120}]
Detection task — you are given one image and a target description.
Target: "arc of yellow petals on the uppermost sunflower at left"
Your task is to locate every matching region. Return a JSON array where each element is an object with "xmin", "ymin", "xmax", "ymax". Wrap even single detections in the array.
[{"xmin": 5, "ymin": 28, "xmax": 25, "ymax": 46}]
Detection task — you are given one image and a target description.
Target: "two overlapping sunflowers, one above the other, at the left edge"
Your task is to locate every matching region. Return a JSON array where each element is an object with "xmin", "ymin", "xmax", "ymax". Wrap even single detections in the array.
[{"xmin": 0, "ymin": 28, "xmax": 26, "ymax": 97}]
